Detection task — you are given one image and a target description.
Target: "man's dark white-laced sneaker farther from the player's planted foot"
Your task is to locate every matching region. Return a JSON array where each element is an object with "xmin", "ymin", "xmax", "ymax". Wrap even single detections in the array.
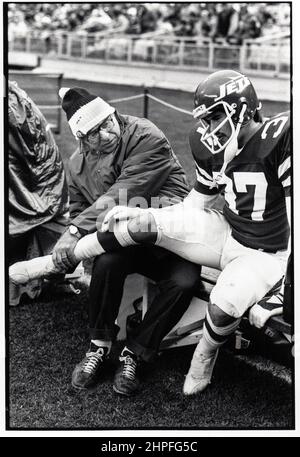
[{"xmin": 72, "ymin": 343, "xmax": 108, "ymax": 389}]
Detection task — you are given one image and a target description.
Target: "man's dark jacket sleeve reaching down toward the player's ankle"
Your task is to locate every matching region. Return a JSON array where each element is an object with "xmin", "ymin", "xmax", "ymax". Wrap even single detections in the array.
[{"xmin": 72, "ymin": 129, "xmax": 178, "ymax": 233}]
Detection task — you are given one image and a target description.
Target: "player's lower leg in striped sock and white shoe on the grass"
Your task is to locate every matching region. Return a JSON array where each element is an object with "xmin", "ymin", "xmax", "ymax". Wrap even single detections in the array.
[{"xmin": 183, "ymin": 303, "xmax": 240, "ymax": 395}]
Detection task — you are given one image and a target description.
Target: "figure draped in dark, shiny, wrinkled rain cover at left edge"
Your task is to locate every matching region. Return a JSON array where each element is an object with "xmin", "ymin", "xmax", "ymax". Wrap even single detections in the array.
[{"xmin": 8, "ymin": 81, "xmax": 68, "ymax": 305}]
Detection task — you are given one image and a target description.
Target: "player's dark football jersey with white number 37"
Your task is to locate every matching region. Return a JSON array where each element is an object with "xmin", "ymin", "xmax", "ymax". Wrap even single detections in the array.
[{"xmin": 190, "ymin": 112, "xmax": 291, "ymax": 252}]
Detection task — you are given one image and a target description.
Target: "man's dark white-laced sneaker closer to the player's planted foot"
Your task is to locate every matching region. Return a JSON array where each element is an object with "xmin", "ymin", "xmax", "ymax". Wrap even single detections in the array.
[{"xmin": 113, "ymin": 348, "xmax": 139, "ymax": 397}]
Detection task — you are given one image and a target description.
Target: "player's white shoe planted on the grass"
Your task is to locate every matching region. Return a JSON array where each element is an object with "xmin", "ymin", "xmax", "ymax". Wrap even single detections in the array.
[{"xmin": 183, "ymin": 348, "xmax": 219, "ymax": 395}]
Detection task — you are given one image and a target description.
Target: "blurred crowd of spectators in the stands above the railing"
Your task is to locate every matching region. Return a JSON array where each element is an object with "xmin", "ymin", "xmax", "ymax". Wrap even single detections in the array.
[{"xmin": 8, "ymin": 3, "xmax": 290, "ymax": 44}]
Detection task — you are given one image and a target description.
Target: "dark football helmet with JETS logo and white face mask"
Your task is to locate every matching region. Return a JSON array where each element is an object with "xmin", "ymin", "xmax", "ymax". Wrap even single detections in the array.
[{"xmin": 193, "ymin": 70, "xmax": 260, "ymax": 154}]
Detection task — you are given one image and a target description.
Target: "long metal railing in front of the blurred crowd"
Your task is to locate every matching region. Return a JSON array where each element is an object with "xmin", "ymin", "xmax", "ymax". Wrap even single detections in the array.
[{"xmin": 9, "ymin": 31, "xmax": 290, "ymax": 77}]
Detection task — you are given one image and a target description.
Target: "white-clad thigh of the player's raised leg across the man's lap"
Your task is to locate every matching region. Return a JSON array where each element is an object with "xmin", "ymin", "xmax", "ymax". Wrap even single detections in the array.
[{"xmin": 151, "ymin": 205, "xmax": 230, "ymax": 268}]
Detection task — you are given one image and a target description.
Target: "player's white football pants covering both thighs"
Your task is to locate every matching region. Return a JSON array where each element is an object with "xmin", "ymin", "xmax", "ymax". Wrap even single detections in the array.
[{"xmin": 149, "ymin": 205, "xmax": 287, "ymax": 318}]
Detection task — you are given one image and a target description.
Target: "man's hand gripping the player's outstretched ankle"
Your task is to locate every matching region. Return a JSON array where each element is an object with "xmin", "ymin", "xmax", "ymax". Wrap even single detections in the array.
[{"xmin": 52, "ymin": 230, "xmax": 79, "ymax": 272}]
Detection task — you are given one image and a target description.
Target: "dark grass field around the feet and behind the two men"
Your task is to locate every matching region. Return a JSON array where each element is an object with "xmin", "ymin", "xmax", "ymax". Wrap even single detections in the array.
[{"xmin": 7, "ymin": 76, "xmax": 294, "ymax": 431}]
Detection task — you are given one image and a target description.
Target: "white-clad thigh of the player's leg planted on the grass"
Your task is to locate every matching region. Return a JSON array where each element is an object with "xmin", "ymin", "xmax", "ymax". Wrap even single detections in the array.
[{"xmin": 210, "ymin": 252, "xmax": 282, "ymax": 318}]
